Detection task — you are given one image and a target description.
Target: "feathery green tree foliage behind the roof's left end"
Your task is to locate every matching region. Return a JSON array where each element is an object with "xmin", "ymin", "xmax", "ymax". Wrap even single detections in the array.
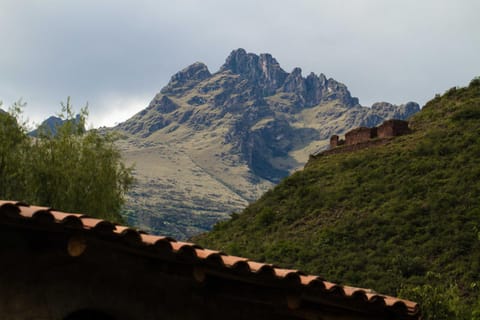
[{"xmin": 0, "ymin": 99, "xmax": 133, "ymax": 221}]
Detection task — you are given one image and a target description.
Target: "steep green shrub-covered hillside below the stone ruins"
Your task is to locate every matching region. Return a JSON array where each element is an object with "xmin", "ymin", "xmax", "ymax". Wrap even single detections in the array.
[{"xmin": 195, "ymin": 78, "xmax": 480, "ymax": 319}]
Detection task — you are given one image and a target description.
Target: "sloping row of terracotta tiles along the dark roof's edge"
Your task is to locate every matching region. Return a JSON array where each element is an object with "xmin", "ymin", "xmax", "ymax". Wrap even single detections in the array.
[{"xmin": 0, "ymin": 200, "xmax": 419, "ymax": 319}]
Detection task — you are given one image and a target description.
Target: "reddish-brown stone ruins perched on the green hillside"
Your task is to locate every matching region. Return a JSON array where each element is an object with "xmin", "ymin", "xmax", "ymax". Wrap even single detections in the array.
[{"xmin": 330, "ymin": 119, "xmax": 410, "ymax": 149}]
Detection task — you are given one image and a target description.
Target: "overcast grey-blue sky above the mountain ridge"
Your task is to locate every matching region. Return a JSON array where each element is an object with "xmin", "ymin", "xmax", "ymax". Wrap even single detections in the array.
[{"xmin": 0, "ymin": 0, "xmax": 480, "ymax": 126}]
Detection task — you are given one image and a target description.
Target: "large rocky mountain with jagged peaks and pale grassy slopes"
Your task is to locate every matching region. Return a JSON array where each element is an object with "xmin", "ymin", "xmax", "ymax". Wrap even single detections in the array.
[{"xmin": 114, "ymin": 49, "xmax": 419, "ymax": 239}]
